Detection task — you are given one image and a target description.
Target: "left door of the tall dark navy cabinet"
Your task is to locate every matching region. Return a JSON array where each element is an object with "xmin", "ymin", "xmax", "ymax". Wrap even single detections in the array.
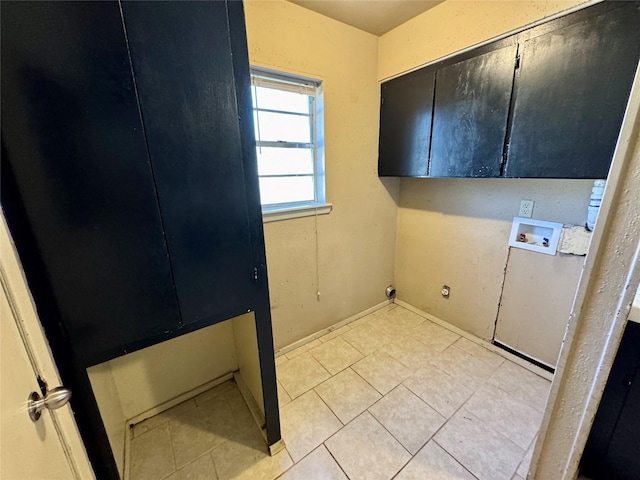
[{"xmin": 1, "ymin": 1, "xmax": 180, "ymax": 366}]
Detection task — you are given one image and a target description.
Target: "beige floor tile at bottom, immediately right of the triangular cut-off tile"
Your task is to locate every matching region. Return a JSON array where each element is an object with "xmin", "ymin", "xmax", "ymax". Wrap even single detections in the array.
[{"xmin": 434, "ymin": 408, "xmax": 525, "ymax": 480}]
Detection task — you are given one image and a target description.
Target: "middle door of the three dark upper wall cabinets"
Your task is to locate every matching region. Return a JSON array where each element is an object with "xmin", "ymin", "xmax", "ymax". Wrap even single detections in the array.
[{"xmin": 429, "ymin": 45, "xmax": 517, "ymax": 177}]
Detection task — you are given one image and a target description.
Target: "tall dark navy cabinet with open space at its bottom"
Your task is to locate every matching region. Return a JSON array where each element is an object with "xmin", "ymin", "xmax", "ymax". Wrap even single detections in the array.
[{"xmin": 0, "ymin": 1, "xmax": 280, "ymax": 478}]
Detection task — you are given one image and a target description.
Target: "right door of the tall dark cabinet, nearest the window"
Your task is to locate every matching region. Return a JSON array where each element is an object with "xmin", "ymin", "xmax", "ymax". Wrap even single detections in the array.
[{"xmin": 122, "ymin": 2, "xmax": 257, "ymax": 328}]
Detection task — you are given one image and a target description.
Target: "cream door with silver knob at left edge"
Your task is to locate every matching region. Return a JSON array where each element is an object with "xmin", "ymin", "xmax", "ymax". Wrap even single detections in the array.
[{"xmin": 0, "ymin": 215, "xmax": 95, "ymax": 480}]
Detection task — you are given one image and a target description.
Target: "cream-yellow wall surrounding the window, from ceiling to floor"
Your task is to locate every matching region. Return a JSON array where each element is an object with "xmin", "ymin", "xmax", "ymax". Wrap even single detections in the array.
[{"xmin": 245, "ymin": 0, "xmax": 398, "ymax": 349}]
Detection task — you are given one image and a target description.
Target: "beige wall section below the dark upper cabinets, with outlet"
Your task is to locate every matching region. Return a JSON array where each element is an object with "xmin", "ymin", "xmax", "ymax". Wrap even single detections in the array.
[{"xmin": 395, "ymin": 179, "xmax": 593, "ymax": 340}]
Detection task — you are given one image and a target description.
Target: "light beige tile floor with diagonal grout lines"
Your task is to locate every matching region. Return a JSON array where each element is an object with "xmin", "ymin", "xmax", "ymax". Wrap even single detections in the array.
[{"xmin": 130, "ymin": 304, "xmax": 550, "ymax": 480}]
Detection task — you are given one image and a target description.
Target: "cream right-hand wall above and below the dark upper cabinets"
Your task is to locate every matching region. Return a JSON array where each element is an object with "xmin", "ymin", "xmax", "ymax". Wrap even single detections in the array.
[{"xmin": 378, "ymin": 1, "xmax": 592, "ymax": 340}]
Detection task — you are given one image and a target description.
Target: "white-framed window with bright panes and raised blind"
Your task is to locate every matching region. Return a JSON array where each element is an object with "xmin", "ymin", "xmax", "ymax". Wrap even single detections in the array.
[{"xmin": 251, "ymin": 68, "xmax": 325, "ymax": 218}]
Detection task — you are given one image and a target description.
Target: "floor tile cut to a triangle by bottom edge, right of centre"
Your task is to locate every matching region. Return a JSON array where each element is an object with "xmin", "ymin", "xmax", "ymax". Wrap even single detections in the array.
[{"xmin": 395, "ymin": 441, "xmax": 475, "ymax": 480}]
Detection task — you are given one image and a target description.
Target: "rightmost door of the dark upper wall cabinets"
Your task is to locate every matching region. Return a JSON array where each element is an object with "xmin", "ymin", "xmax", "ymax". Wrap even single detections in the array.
[{"xmin": 506, "ymin": 2, "xmax": 640, "ymax": 178}]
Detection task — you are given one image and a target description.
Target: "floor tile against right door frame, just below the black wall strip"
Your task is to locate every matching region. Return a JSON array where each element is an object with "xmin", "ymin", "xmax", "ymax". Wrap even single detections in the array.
[{"xmin": 488, "ymin": 361, "xmax": 551, "ymax": 412}]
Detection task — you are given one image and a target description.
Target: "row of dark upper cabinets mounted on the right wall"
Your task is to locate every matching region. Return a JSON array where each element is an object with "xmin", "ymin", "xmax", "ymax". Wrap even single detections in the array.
[{"xmin": 378, "ymin": 2, "xmax": 640, "ymax": 178}]
